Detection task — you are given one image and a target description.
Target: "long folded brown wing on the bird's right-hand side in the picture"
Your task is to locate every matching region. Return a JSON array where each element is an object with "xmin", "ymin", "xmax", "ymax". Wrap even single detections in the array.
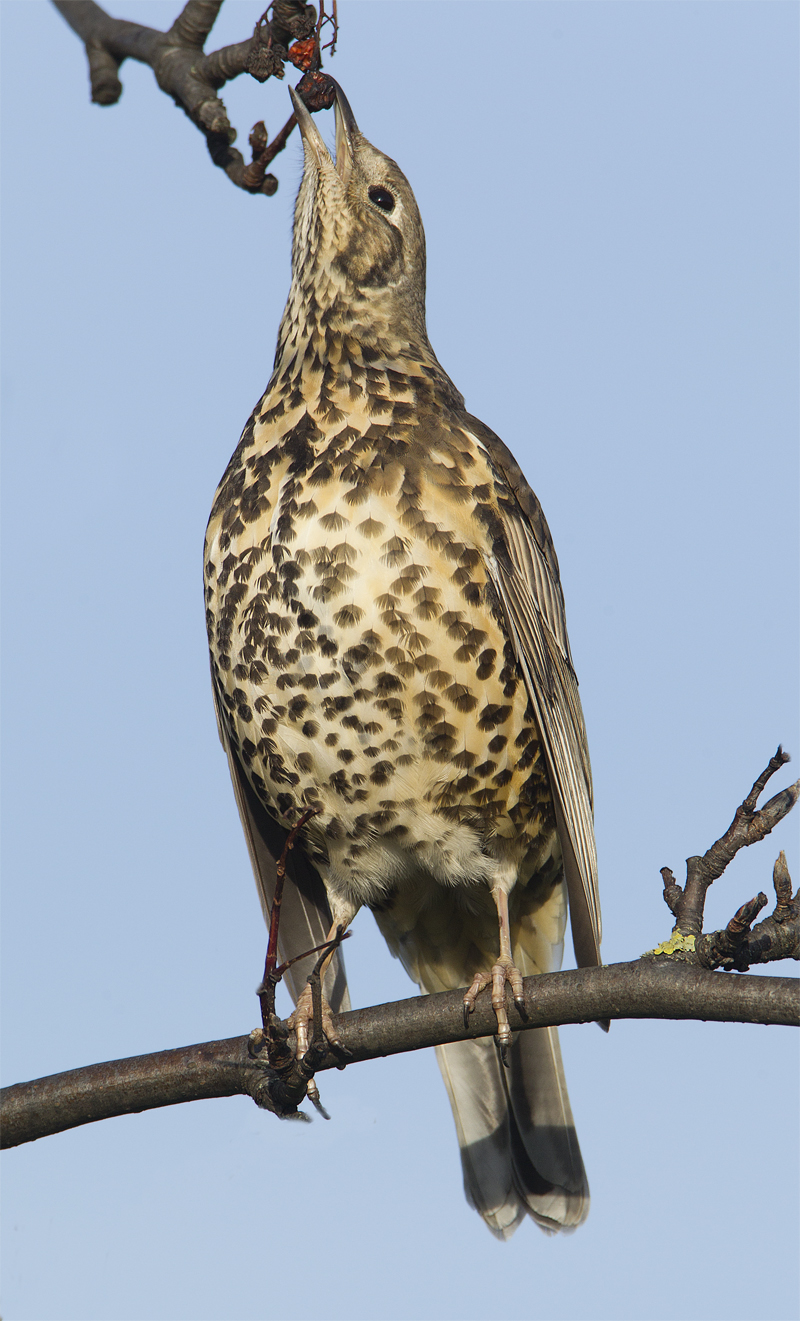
[{"xmin": 469, "ymin": 417, "xmax": 601, "ymax": 967}]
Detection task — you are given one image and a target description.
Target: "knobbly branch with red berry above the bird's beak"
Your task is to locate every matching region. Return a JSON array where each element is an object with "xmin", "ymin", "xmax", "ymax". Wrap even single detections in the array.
[{"xmin": 53, "ymin": 0, "xmax": 330, "ymax": 196}]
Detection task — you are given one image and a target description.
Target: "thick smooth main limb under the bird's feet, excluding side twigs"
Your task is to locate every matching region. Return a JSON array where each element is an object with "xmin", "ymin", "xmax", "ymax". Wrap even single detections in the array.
[{"xmin": 0, "ymin": 962, "xmax": 800, "ymax": 1147}]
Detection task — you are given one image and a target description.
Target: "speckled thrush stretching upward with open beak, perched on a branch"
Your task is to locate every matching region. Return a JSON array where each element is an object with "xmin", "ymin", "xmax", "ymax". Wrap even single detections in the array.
[{"xmin": 205, "ymin": 79, "xmax": 601, "ymax": 1239}]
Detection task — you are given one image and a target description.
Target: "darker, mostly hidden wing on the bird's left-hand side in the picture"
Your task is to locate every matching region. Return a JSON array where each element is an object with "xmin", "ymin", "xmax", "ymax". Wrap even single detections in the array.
[{"xmin": 211, "ymin": 678, "xmax": 350, "ymax": 1013}]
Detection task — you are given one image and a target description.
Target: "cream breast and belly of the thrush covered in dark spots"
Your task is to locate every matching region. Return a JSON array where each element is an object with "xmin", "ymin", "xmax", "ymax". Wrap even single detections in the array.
[{"xmin": 206, "ymin": 396, "xmax": 554, "ymax": 902}]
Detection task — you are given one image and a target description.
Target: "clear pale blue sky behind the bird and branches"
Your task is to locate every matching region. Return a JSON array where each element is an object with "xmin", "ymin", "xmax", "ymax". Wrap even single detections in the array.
[{"xmin": 0, "ymin": 0, "xmax": 800, "ymax": 1321}]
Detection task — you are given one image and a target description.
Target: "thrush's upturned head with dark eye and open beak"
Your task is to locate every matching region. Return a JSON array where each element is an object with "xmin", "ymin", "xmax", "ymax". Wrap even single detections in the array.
[{"xmin": 290, "ymin": 79, "xmax": 425, "ymax": 337}]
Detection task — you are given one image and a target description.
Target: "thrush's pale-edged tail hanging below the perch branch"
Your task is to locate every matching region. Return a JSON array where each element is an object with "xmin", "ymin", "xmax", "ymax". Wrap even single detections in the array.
[{"xmin": 436, "ymin": 1028, "xmax": 589, "ymax": 1239}]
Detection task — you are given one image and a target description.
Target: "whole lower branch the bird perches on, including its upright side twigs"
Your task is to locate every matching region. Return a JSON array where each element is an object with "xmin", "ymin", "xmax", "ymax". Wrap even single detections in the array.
[{"xmin": 0, "ymin": 748, "xmax": 800, "ymax": 1147}]
